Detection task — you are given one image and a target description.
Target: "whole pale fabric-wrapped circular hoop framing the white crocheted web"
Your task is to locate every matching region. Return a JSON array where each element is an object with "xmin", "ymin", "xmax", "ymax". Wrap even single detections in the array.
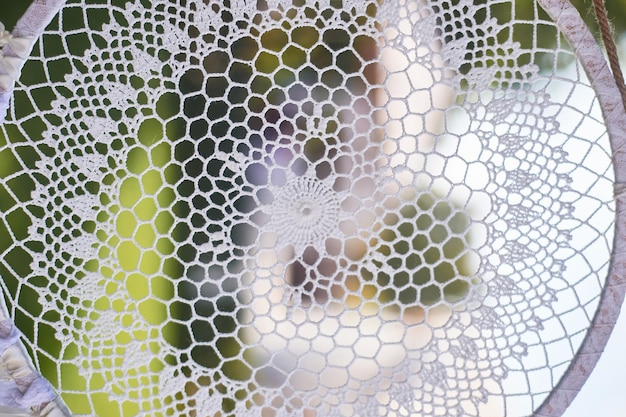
[{"xmin": 0, "ymin": 0, "xmax": 626, "ymax": 417}]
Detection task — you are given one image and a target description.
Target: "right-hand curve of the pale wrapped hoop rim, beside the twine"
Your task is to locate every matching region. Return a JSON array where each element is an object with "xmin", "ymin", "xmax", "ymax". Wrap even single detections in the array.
[{"xmin": 534, "ymin": 0, "xmax": 626, "ymax": 417}]
